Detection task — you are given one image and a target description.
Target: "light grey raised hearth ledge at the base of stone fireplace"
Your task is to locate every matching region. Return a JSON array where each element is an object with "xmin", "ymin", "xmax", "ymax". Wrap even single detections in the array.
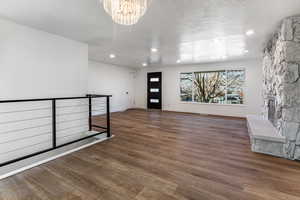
[{"xmin": 247, "ymin": 115, "xmax": 286, "ymax": 157}]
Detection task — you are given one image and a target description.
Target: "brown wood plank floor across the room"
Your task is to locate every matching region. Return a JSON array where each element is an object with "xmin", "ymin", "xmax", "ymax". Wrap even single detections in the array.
[{"xmin": 0, "ymin": 110, "xmax": 300, "ymax": 200}]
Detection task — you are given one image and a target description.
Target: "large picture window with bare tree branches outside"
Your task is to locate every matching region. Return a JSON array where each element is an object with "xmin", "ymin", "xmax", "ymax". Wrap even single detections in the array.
[{"xmin": 180, "ymin": 70, "xmax": 245, "ymax": 104}]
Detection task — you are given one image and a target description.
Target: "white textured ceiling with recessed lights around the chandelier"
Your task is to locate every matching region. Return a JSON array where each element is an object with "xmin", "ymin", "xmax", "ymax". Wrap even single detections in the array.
[{"xmin": 0, "ymin": 0, "xmax": 300, "ymax": 67}]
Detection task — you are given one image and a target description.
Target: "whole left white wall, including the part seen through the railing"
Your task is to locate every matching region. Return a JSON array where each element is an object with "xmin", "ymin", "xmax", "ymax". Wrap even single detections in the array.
[{"xmin": 0, "ymin": 19, "xmax": 88, "ymax": 166}]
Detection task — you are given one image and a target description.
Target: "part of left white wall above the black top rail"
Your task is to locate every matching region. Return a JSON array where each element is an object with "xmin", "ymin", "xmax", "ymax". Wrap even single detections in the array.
[{"xmin": 0, "ymin": 19, "xmax": 88, "ymax": 99}]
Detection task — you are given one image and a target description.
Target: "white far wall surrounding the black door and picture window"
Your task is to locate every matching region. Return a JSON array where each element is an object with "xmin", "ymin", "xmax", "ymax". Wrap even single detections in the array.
[{"xmin": 135, "ymin": 60, "xmax": 262, "ymax": 117}]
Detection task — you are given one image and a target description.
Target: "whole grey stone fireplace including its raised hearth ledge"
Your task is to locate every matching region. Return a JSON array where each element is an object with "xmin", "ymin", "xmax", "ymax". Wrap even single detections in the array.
[{"xmin": 247, "ymin": 16, "xmax": 300, "ymax": 160}]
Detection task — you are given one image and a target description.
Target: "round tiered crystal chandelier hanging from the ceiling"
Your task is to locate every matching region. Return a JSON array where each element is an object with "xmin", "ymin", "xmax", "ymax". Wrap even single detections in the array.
[{"xmin": 103, "ymin": 0, "xmax": 150, "ymax": 25}]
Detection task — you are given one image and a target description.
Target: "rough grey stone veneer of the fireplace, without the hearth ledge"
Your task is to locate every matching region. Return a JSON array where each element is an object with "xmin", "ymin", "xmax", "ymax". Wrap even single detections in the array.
[{"xmin": 263, "ymin": 16, "xmax": 300, "ymax": 160}]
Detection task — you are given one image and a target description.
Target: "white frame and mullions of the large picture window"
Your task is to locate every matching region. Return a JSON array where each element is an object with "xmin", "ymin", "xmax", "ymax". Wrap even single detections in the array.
[{"xmin": 178, "ymin": 67, "xmax": 248, "ymax": 107}]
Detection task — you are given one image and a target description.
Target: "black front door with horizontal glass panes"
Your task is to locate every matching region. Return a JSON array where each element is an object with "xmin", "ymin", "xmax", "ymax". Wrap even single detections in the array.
[{"xmin": 147, "ymin": 72, "xmax": 162, "ymax": 109}]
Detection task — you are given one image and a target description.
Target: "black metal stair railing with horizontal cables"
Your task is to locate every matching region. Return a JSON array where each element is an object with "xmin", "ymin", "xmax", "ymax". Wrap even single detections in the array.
[{"xmin": 0, "ymin": 94, "xmax": 111, "ymax": 168}]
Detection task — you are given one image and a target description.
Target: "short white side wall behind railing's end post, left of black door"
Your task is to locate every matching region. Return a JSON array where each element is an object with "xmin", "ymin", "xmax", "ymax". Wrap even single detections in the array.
[{"xmin": 88, "ymin": 61, "xmax": 135, "ymax": 112}]
